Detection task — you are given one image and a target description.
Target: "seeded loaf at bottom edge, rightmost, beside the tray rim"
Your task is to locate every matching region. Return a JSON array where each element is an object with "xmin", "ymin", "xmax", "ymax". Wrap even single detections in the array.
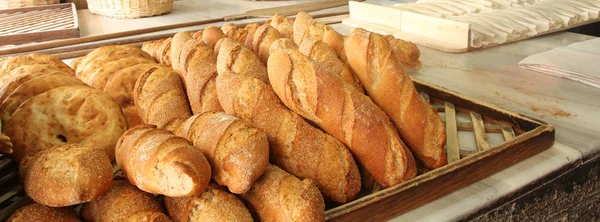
[{"xmin": 240, "ymin": 165, "xmax": 325, "ymax": 222}]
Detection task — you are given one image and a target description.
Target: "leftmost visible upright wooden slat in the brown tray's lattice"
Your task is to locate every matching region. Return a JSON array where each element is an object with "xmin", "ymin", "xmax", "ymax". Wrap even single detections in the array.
[{"xmin": 445, "ymin": 102, "xmax": 460, "ymax": 163}]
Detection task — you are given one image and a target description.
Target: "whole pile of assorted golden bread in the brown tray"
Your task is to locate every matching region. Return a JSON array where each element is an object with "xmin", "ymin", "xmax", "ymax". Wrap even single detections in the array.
[{"xmin": 0, "ymin": 13, "xmax": 446, "ymax": 221}]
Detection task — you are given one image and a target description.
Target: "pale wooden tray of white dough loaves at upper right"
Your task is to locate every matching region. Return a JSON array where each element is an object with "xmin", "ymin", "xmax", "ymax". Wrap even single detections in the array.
[{"xmin": 343, "ymin": 1, "xmax": 600, "ymax": 53}]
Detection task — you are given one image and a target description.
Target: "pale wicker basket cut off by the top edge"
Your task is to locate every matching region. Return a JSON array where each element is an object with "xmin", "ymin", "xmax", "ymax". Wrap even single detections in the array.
[{"xmin": 87, "ymin": 0, "xmax": 173, "ymax": 18}]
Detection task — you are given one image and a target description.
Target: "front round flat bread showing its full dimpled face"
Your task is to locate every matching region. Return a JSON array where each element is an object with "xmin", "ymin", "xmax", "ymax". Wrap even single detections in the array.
[{"xmin": 2, "ymin": 85, "xmax": 127, "ymax": 161}]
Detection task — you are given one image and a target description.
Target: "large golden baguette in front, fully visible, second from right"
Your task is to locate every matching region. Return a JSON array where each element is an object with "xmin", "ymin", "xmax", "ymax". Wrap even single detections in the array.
[{"xmin": 267, "ymin": 50, "xmax": 416, "ymax": 187}]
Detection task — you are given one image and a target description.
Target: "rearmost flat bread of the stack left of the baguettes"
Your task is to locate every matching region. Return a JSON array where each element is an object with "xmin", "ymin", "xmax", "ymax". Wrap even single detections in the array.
[{"xmin": 76, "ymin": 45, "xmax": 154, "ymax": 82}]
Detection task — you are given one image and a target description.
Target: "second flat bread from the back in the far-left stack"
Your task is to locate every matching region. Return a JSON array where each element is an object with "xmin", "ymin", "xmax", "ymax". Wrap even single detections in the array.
[{"xmin": 0, "ymin": 68, "xmax": 73, "ymax": 103}]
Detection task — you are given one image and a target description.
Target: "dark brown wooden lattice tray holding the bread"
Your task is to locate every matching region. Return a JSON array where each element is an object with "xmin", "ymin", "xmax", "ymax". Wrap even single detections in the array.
[{"xmin": 0, "ymin": 78, "xmax": 554, "ymax": 221}]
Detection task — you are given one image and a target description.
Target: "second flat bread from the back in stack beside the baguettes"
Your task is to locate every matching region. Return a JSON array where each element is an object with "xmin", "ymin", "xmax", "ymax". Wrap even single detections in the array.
[{"xmin": 88, "ymin": 57, "xmax": 156, "ymax": 90}]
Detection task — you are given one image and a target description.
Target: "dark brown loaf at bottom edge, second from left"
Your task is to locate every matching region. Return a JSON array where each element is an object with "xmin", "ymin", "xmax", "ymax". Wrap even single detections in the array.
[{"xmin": 81, "ymin": 178, "xmax": 171, "ymax": 222}]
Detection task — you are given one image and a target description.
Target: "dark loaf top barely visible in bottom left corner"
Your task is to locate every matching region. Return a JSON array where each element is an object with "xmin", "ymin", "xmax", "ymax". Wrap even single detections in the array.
[{"xmin": 6, "ymin": 203, "xmax": 81, "ymax": 222}]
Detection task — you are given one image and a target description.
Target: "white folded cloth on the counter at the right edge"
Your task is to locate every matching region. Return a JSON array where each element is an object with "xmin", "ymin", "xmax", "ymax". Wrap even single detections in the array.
[{"xmin": 519, "ymin": 38, "xmax": 600, "ymax": 88}]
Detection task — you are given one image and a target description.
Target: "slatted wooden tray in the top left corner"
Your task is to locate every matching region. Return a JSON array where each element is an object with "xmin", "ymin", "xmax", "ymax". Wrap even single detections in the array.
[{"xmin": 0, "ymin": 3, "xmax": 79, "ymax": 46}]
